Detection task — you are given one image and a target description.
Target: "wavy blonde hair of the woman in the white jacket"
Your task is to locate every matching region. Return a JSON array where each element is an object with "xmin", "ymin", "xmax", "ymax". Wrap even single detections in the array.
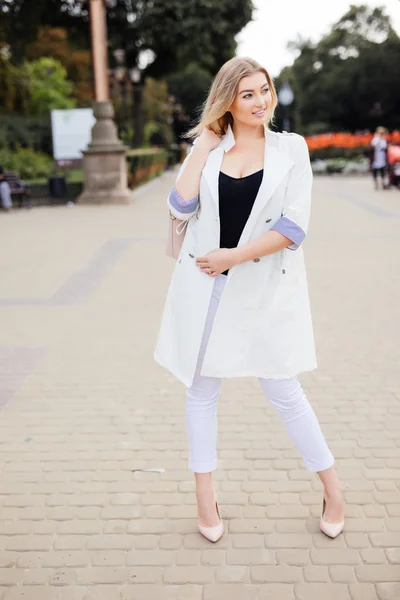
[{"xmin": 184, "ymin": 56, "xmax": 278, "ymax": 138}]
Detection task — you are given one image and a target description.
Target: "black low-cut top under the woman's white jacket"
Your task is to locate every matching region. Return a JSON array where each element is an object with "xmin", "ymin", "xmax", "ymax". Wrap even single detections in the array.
[{"xmin": 218, "ymin": 169, "xmax": 263, "ymax": 275}]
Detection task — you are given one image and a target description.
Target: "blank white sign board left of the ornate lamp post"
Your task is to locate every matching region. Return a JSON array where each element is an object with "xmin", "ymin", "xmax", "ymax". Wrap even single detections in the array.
[{"xmin": 51, "ymin": 108, "xmax": 96, "ymax": 161}]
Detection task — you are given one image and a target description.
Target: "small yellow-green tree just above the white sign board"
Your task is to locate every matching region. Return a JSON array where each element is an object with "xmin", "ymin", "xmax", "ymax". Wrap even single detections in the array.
[{"xmin": 24, "ymin": 58, "xmax": 76, "ymax": 116}]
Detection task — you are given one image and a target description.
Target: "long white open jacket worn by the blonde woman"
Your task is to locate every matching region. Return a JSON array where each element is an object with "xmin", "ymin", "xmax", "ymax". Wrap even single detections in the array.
[{"xmin": 155, "ymin": 128, "xmax": 316, "ymax": 387}]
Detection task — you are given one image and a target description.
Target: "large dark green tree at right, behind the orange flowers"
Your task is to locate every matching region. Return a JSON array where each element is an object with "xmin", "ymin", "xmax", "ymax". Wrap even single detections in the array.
[{"xmin": 286, "ymin": 5, "xmax": 400, "ymax": 131}]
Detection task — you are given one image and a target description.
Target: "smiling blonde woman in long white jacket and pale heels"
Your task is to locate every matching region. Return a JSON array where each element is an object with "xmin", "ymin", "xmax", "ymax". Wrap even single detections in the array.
[{"xmin": 155, "ymin": 58, "xmax": 344, "ymax": 542}]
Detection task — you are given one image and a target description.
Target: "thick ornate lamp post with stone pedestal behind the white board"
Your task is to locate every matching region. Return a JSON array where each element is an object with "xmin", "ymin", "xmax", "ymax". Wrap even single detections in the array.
[{"xmin": 78, "ymin": 0, "xmax": 131, "ymax": 204}]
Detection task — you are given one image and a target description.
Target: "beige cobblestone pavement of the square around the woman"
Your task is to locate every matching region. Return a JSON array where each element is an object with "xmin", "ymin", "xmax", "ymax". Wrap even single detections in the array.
[{"xmin": 0, "ymin": 173, "xmax": 400, "ymax": 600}]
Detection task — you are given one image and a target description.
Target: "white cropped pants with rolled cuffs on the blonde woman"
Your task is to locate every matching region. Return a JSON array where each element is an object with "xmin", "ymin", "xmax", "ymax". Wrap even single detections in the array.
[{"xmin": 186, "ymin": 275, "xmax": 334, "ymax": 473}]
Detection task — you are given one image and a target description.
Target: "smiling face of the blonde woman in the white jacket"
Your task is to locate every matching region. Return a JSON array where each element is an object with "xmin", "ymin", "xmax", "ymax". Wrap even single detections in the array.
[{"xmin": 229, "ymin": 72, "xmax": 272, "ymax": 127}]
